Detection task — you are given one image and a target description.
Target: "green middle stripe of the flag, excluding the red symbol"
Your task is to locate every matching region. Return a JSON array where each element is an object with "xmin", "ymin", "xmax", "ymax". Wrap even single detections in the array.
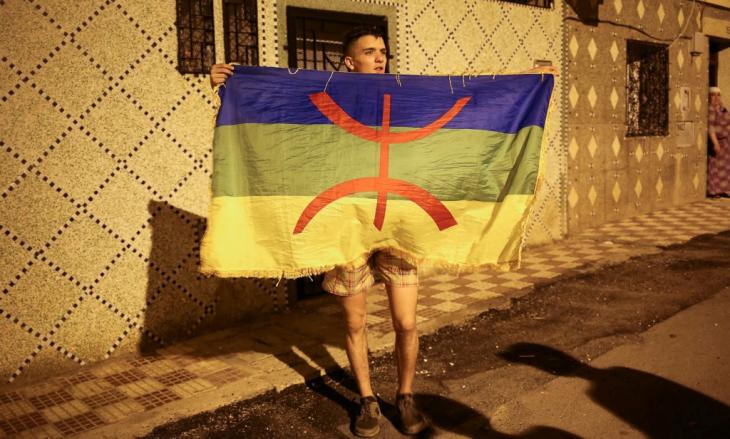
[{"xmin": 213, "ymin": 124, "xmax": 543, "ymax": 201}]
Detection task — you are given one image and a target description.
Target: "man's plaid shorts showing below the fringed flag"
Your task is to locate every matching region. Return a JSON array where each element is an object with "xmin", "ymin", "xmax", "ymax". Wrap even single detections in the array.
[{"xmin": 322, "ymin": 250, "xmax": 418, "ymax": 296}]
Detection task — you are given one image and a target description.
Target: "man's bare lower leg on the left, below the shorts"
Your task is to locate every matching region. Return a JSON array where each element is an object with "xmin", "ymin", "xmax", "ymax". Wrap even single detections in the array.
[{"xmin": 340, "ymin": 291, "xmax": 374, "ymax": 398}]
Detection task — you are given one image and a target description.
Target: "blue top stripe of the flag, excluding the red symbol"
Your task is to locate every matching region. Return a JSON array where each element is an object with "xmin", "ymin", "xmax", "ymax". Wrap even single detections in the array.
[{"xmin": 216, "ymin": 66, "xmax": 554, "ymax": 133}]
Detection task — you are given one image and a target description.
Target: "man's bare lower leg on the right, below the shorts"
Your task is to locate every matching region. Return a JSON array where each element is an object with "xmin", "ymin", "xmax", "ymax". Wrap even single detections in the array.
[{"xmin": 386, "ymin": 285, "xmax": 418, "ymax": 394}]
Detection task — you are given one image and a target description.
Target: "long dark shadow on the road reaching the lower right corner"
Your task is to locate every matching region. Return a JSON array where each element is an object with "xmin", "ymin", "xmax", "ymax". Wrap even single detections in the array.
[{"xmin": 498, "ymin": 343, "xmax": 730, "ymax": 438}]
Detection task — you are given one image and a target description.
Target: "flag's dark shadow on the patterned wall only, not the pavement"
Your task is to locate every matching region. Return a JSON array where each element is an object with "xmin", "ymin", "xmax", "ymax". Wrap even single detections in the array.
[{"xmin": 139, "ymin": 200, "xmax": 278, "ymax": 353}]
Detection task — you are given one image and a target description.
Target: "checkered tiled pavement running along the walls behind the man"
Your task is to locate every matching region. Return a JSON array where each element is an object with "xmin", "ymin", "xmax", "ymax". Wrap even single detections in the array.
[{"xmin": 0, "ymin": 199, "xmax": 730, "ymax": 437}]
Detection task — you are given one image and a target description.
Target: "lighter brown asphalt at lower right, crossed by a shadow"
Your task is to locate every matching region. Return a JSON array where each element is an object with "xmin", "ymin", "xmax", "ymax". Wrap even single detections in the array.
[{"xmin": 489, "ymin": 288, "xmax": 730, "ymax": 439}]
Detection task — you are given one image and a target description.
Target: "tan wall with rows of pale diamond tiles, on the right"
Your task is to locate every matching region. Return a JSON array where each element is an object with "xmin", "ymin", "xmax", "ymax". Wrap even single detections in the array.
[{"xmin": 566, "ymin": 0, "xmax": 708, "ymax": 234}]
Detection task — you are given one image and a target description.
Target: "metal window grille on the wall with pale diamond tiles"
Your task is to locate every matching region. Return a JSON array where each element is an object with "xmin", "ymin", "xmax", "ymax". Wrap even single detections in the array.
[{"xmin": 626, "ymin": 40, "xmax": 669, "ymax": 136}]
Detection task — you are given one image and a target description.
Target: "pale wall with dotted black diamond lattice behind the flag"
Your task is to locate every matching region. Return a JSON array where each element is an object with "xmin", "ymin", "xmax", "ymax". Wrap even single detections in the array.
[{"xmin": 0, "ymin": 0, "xmax": 566, "ymax": 382}]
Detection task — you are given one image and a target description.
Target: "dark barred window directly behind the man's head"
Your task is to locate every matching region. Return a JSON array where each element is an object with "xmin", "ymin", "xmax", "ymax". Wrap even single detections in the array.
[{"xmin": 286, "ymin": 7, "xmax": 388, "ymax": 71}]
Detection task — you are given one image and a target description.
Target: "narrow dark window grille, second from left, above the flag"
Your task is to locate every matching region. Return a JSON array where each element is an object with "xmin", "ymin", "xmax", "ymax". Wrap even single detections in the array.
[{"xmin": 223, "ymin": 0, "xmax": 259, "ymax": 66}]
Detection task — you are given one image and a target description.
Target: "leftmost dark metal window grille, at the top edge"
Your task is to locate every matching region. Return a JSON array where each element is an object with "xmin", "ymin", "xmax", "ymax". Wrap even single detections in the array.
[{"xmin": 175, "ymin": 0, "xmax": 215, "ymax": 73}]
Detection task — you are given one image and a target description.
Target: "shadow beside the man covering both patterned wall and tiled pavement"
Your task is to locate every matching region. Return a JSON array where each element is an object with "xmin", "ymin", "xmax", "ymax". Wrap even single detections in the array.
[{"xmin": 138, "ymin": 201, "xmax": 344, "ymax": 380}]
